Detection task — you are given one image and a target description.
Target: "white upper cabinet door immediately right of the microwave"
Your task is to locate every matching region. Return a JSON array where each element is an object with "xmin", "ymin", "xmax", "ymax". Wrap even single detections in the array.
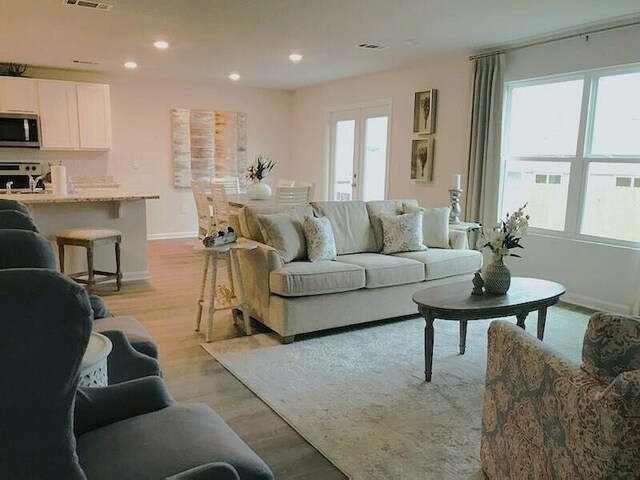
[{"xmin": 38, "ymin": 80, "xmax": 80, "ymax": 150}]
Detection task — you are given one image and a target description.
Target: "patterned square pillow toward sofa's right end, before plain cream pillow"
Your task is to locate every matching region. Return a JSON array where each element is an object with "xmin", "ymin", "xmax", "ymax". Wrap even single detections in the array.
[{"xmin": 380, "ymin": 211, "xmax": 427, "ymax": 254}]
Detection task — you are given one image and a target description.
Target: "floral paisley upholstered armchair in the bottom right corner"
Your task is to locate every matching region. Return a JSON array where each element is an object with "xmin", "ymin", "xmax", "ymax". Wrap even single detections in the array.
[{"xmin": 480, "ymin": 313, "xmax": 640, "ymax": 480}]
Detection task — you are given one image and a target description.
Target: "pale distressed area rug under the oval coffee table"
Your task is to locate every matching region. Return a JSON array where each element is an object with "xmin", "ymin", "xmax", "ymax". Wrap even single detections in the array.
[{"xmin": 203, "ymin": 307, "xmax": 588, "ymax": 480}]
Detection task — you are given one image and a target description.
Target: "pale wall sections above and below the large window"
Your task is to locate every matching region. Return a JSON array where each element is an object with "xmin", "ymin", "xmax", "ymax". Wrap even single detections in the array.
[{"xmin": 505, "ymin": 28, "xmax": 640, "ymax": 315}]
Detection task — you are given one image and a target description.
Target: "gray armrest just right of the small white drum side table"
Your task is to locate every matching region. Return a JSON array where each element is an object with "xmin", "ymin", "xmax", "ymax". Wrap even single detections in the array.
[{"xmin": 101, "ymin": 330, "xmax": 162, "ymax": 385}]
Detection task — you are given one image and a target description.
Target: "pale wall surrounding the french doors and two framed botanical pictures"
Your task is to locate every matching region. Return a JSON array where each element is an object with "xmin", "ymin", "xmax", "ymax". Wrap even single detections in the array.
[{"xmin": 287, "ymin": 57, "xmax": 471, "ymax": 206}]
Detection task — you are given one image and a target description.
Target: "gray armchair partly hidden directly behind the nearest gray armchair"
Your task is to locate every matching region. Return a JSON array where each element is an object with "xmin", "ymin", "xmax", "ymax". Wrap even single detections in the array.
[{"xmin": 0, "ymin": 230, "xmax": 160, "ymax": 384}]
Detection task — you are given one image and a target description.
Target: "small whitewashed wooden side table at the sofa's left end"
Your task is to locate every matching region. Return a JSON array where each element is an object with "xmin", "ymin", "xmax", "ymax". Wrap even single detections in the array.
[{"xmin": 196, "ymin": 239, "xmax": 257, "ymax": 342}]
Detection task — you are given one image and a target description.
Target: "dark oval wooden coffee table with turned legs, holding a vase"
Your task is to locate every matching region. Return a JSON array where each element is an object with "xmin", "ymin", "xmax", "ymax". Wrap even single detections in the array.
[{"xmin": 413, "ymin": 277, "xmax": 566, "ymax": 382}]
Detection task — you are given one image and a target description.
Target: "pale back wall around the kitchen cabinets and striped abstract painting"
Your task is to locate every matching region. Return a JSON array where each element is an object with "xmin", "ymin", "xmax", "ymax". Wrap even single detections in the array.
[{"xmin": 0, "ymin": 70, "xmax": 291, "ymax": 237}]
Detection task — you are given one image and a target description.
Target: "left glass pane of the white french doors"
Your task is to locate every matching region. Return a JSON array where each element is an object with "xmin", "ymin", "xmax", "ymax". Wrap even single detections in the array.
[{"xmin": 331, "ymin": 119, "xmax": 356, "ymax": 200}]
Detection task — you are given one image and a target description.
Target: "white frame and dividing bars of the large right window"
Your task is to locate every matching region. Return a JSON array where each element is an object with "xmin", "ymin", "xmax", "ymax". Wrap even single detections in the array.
[{"xmin": 498, "ymin": 64, "xmax": 640, "ymax": 249}]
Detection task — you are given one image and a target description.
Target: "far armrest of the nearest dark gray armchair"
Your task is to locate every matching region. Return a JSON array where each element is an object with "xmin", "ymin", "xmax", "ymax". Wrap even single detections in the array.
[{"xmin": 73, "ymin": 377, "xmax": 175, "ymax": 436}]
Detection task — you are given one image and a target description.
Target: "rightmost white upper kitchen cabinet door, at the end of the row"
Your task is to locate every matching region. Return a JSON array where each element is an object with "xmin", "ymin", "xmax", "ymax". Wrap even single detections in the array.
[{"xmin": 76, "ymin": 83, "xmax": 111, "ymax": 150}]
